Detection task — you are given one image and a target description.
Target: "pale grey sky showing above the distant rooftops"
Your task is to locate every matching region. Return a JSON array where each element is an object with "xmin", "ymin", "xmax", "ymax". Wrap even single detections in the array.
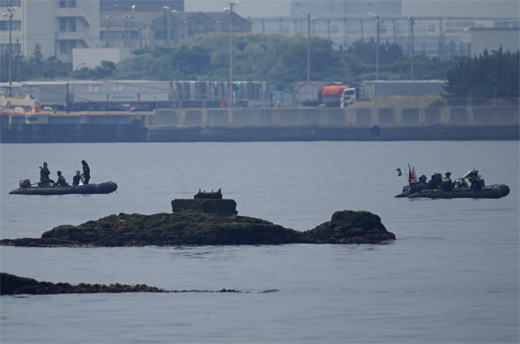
[{"xmin": 184, "ymin": 0, "xmax": 520, "ymax": 18}]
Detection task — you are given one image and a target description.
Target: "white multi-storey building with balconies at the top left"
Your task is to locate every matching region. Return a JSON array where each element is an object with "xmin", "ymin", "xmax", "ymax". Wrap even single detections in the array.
[{"xmin": 0, "ymin": 0, "xmax": 100, "ymax": 61}]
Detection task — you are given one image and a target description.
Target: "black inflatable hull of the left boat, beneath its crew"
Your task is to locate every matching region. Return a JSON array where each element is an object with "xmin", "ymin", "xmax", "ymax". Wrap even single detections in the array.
[{"xmin": 9, "ymin": 182, "xmax": 117, "ymax": 195}]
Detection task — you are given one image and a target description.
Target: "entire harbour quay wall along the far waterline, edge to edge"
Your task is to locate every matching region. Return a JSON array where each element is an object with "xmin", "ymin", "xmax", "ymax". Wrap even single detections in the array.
[{"xmin": 0, "ymin": 105, "xmax": 520, "ymax": 143}]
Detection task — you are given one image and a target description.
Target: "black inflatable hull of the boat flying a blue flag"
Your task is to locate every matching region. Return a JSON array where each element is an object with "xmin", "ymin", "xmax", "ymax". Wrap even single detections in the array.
[{"xmin": 395, "ymin": 184, "xmax": 510, "ymax": 199}]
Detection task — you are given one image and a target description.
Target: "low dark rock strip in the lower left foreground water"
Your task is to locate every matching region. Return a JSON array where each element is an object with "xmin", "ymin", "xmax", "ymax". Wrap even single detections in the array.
[{"xmin": 0, "ymin": 272, "xmax": 168, "ymax": 295}]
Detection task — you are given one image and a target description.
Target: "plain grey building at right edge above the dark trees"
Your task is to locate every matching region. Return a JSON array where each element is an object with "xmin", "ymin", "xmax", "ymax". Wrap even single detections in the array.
[{"xmin": 471, "ymin": 27, "xmax": 520, "ymax": 56}]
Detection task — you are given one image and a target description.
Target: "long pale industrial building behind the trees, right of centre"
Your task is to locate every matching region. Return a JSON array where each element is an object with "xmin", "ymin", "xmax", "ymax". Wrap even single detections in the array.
[{"xmin": 251, "ymin": 15, "xmax": 520, "ymax": 58}]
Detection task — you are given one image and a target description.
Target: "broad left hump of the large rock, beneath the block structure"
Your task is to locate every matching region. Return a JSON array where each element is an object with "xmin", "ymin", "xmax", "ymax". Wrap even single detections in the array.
[{"xmin": 1, "ymin": 211, "xmax": 299, "ymax": 246}]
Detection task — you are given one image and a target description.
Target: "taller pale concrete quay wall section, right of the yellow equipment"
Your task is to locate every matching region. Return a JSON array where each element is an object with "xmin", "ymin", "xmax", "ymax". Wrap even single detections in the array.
[{"xmin": 145, "ymin": 106, "xmax": 519, "ymax": 142}]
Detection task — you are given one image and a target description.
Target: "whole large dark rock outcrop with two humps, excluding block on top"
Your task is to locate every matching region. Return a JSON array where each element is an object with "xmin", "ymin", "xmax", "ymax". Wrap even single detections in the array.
[{"xmin": 0, "ymin": 210, "xmax": 395, "ymax": 247}]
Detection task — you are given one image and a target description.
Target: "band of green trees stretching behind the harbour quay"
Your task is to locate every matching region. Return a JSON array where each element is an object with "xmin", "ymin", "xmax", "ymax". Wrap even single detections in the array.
[{"xmin": 0, "ymin": 34, "xmax": 520, "ymax": 97}]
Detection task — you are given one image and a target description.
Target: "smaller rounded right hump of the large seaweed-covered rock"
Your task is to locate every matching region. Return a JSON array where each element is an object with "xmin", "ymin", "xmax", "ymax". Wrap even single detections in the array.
[{"xmin": 302, "ymin": 210, "xmax": 395, "ymax": 244}]
